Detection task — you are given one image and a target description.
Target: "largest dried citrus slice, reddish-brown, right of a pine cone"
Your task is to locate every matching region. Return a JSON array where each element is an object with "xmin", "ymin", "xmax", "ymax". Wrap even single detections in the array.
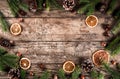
[{"xmin": 92, "ymin": 50, "xmax": 110, "ymax": 66}]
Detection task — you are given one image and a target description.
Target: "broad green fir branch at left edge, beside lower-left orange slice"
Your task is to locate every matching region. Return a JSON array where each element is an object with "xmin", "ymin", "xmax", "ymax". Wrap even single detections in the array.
[{"xmin": 0, "ymin": 48, "xmax": 19, "ymax": 71}]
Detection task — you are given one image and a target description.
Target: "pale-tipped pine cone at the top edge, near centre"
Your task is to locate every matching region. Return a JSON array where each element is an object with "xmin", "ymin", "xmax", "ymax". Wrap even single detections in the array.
[{"xmin": 63, "ymin": 0, "xmax": 75, "ymax": 10}]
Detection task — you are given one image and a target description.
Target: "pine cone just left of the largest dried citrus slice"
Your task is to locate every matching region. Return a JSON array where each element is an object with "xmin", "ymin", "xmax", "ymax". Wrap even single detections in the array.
[{"xmin": 81, "ymin": 59, "xmax": 94, "ymax": 72}]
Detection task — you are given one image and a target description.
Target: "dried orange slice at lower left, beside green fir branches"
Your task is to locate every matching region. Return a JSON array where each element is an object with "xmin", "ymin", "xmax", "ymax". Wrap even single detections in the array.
[{"xmin": 20, "ymin": 58, "xmax": 31, "ymax": 70}]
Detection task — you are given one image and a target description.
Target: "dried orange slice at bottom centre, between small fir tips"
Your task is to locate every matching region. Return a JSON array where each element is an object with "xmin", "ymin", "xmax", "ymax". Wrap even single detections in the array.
[{"xmin": 63, "ymin": 61, "xmax": 75, "ymax": 73}]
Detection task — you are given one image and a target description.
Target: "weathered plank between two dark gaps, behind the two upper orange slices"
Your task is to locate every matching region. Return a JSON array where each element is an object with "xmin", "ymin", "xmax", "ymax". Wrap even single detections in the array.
[{"xmin": 0, "ymin": 18, "xmax": 111, "ymax": 41}]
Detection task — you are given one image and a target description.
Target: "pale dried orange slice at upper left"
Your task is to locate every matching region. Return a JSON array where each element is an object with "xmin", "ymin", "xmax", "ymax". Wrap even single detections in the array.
[{"xmin": 10, "ymin": 23, "xmax": 22, "ymax": 35}]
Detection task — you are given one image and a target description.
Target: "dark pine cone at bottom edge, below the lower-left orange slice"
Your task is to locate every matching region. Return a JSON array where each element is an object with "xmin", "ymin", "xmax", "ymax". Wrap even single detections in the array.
[{"xmin": 8, "ymin": 69, "xmax": 20, "ymax": 79}]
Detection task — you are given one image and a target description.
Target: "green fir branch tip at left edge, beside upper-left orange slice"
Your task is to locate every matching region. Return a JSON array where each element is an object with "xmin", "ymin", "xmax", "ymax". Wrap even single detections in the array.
[{"xmin": 0, "ymin": 11, "xmax": 9, "ymax": 32}]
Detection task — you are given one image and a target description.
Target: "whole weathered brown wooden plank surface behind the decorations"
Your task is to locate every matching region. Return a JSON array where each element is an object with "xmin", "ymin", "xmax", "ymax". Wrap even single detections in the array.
[{"xmin": 0, "ymin": 0, "xmax": 120, "ymax": 79}]
